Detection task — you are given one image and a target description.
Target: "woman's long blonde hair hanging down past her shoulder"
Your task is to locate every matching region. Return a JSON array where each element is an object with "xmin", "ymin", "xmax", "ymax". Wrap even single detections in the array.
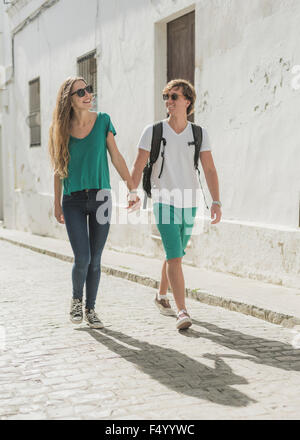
[{"xmin": 48, "ymin": 76, "xmax": 87, "ymax": 178}]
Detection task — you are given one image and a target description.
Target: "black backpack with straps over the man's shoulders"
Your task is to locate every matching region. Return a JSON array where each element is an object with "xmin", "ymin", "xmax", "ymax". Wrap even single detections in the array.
[{"xmin": 143, "ymin": 121, "xmax": 209, "ymax": 209}]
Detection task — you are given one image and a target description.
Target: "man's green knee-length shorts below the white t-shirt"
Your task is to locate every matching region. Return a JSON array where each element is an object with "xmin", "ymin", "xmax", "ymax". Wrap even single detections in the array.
[{"xmin": 153, "ymin": 203, "xmax": 197, "ymax": 260}]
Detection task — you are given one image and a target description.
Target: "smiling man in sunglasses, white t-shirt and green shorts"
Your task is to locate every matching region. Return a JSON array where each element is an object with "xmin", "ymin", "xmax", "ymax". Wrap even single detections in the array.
[{"xmin": 132, "ymin": 79, "xmax": 221, "ymax": 330}]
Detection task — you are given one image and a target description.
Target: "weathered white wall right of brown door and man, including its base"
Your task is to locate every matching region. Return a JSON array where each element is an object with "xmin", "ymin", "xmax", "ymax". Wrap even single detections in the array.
[{"xmin": 191, "ymin": 0, "xmax": 300, "ymax": 287}]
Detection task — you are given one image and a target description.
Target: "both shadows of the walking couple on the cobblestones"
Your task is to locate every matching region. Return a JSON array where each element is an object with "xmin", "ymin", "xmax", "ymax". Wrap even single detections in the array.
[{"xmin": 78, "ymin": 319, "xmax": 300, "ymax": 407}]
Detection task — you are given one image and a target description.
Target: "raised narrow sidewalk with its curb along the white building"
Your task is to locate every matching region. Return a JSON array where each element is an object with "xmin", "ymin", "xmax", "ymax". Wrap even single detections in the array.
[{"xmin": 0, "ymin": 227, "xmax": 300, "ymax": 327}]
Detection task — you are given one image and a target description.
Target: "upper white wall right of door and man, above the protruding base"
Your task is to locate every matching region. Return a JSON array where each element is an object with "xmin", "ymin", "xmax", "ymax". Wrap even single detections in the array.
[{"xmin": 196, "ymin": 0, "xmax": 300, "ymax": 227}]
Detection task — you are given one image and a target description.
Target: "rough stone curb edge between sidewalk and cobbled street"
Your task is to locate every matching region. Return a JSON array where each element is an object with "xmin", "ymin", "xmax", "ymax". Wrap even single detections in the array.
[{"xmin": 0, "ymin": 237, "xmax": 300, "ymax": 328}]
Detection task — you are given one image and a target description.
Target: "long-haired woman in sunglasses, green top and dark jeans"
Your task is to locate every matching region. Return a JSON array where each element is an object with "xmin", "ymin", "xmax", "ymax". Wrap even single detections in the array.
[{"xmin": 49, "ymin": 77, "xmax": 138, "ymax": 328}]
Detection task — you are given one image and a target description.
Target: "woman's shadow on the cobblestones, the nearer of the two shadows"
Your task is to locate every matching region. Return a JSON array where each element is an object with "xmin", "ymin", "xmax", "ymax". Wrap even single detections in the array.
[{"xmin": 77, "ymin": 328, "xmax": 256, "ymax": 407}]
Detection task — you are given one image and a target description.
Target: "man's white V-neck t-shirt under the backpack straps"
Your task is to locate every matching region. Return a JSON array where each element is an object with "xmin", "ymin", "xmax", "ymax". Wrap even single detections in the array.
[{"xmin": 138, "ymin": 119, "xmax": 211, "ymax": 208}]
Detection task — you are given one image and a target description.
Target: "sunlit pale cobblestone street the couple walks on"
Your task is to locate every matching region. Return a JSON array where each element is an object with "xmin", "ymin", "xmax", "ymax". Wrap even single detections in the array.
[{"xmin": 0, "ymin": 237, "xmax": 300, "ymax": 420}]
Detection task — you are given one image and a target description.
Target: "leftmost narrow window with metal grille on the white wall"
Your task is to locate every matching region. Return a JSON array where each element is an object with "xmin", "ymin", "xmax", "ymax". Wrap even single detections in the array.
[{"xmin": 27, "ymin": 78, "xmax": 41, "ymax": 147}]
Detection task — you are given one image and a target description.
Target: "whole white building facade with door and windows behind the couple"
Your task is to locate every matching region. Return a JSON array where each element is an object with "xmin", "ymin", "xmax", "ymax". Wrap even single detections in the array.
[{"xmin": 0, "ymin": 0, "xmax": 300, "ymax": 287}]
